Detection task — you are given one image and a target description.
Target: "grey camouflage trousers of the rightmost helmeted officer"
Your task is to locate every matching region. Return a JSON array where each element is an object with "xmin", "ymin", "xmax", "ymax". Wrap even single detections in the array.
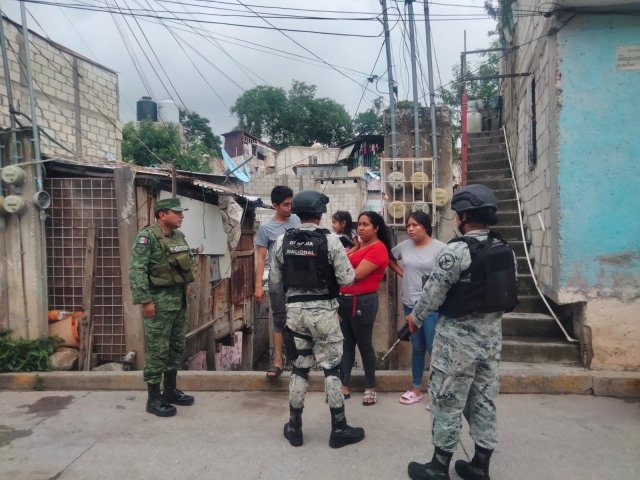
[{"xmin": 429, "ymin": 318, "xmax": 502, "ymax": 452}]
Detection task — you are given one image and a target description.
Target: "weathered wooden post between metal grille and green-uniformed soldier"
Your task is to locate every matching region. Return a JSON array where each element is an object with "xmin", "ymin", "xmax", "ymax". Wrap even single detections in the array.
[{"xmin": 113, "ymin": 167, "xmax": 145, "ymax": 370}]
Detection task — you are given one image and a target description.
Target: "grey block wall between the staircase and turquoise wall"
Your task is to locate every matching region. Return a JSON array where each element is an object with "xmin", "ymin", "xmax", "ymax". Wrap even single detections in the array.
[{"xmin": 504, "ymin": 0, "xmax": 561, "ymax": 296}]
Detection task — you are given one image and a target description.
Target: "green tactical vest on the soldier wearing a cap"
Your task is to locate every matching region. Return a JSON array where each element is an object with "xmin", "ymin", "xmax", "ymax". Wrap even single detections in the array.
[{"xmin": 149, "ymin": 225, "xmax": 194, "ymax": 287}]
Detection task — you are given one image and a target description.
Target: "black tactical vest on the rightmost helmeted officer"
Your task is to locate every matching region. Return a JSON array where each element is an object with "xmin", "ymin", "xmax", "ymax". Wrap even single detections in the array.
[{"xmin": 438, "ymin": 231, "xmax": 518, "ymax": 318}]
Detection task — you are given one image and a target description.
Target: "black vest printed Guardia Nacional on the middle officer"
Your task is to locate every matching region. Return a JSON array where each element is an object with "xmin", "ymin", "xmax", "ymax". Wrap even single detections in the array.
[{"xmin": 282, "ymin": 228, "xmax": 340, "ymax": 303}]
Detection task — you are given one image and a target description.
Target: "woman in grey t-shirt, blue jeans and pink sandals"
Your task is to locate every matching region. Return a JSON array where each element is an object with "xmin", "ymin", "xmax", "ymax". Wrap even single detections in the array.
[{"xmin": 389, "ymin": 212, "xmax": 445, "ymax": 405}]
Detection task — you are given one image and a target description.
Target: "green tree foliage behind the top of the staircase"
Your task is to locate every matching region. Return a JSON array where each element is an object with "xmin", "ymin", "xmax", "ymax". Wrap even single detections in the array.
[{"xmin": 441, "ymin": 39, "xmax": 501, "ymax": 160}]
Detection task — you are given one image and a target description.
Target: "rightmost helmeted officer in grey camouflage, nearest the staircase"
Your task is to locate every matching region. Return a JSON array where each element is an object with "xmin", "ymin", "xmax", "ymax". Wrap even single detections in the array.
[{"xmin": 407, "ymin": 185, "xmax": 518, "ymax": 480}]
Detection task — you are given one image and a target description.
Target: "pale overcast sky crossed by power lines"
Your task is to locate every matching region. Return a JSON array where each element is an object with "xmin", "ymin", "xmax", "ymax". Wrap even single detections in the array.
[{"xmin": 2, "ymin": 0, "xmax": 494, "ymax": 134}]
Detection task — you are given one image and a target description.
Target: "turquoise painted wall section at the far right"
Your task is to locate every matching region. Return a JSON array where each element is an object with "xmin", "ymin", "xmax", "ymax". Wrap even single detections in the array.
[{"xmin": 558, "ymin": 15, "xmax": 640, "ymax": 295}]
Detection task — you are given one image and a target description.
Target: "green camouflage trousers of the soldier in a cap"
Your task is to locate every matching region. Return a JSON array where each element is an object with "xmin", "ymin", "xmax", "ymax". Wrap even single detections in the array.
[{"xmin": 143, "ymin": 305, "xmax": 187, "ymax": 384}]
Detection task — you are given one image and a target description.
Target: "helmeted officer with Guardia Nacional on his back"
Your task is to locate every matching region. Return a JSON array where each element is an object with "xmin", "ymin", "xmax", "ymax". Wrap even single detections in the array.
[{"xmin": 270, "ymin": 190, "xmax": 364, "ymax": 448}]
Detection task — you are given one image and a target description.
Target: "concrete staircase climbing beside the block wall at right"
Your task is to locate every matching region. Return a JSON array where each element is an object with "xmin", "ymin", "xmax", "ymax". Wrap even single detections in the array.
[{"xmin": 467, "ymin": 130, "xmax": 580, "ymax": 364}]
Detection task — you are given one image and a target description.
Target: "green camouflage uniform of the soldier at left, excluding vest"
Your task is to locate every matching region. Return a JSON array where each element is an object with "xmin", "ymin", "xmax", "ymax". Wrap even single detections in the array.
[{"xmin": 129, "ymin": 223, "xmax": 193, "ymax": 384}]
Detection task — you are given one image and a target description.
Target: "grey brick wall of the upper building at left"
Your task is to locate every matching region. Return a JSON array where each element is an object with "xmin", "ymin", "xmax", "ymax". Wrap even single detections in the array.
[{"xmin": 0, "ymin": 19, "xmax": 122, "ymax": 159}]
